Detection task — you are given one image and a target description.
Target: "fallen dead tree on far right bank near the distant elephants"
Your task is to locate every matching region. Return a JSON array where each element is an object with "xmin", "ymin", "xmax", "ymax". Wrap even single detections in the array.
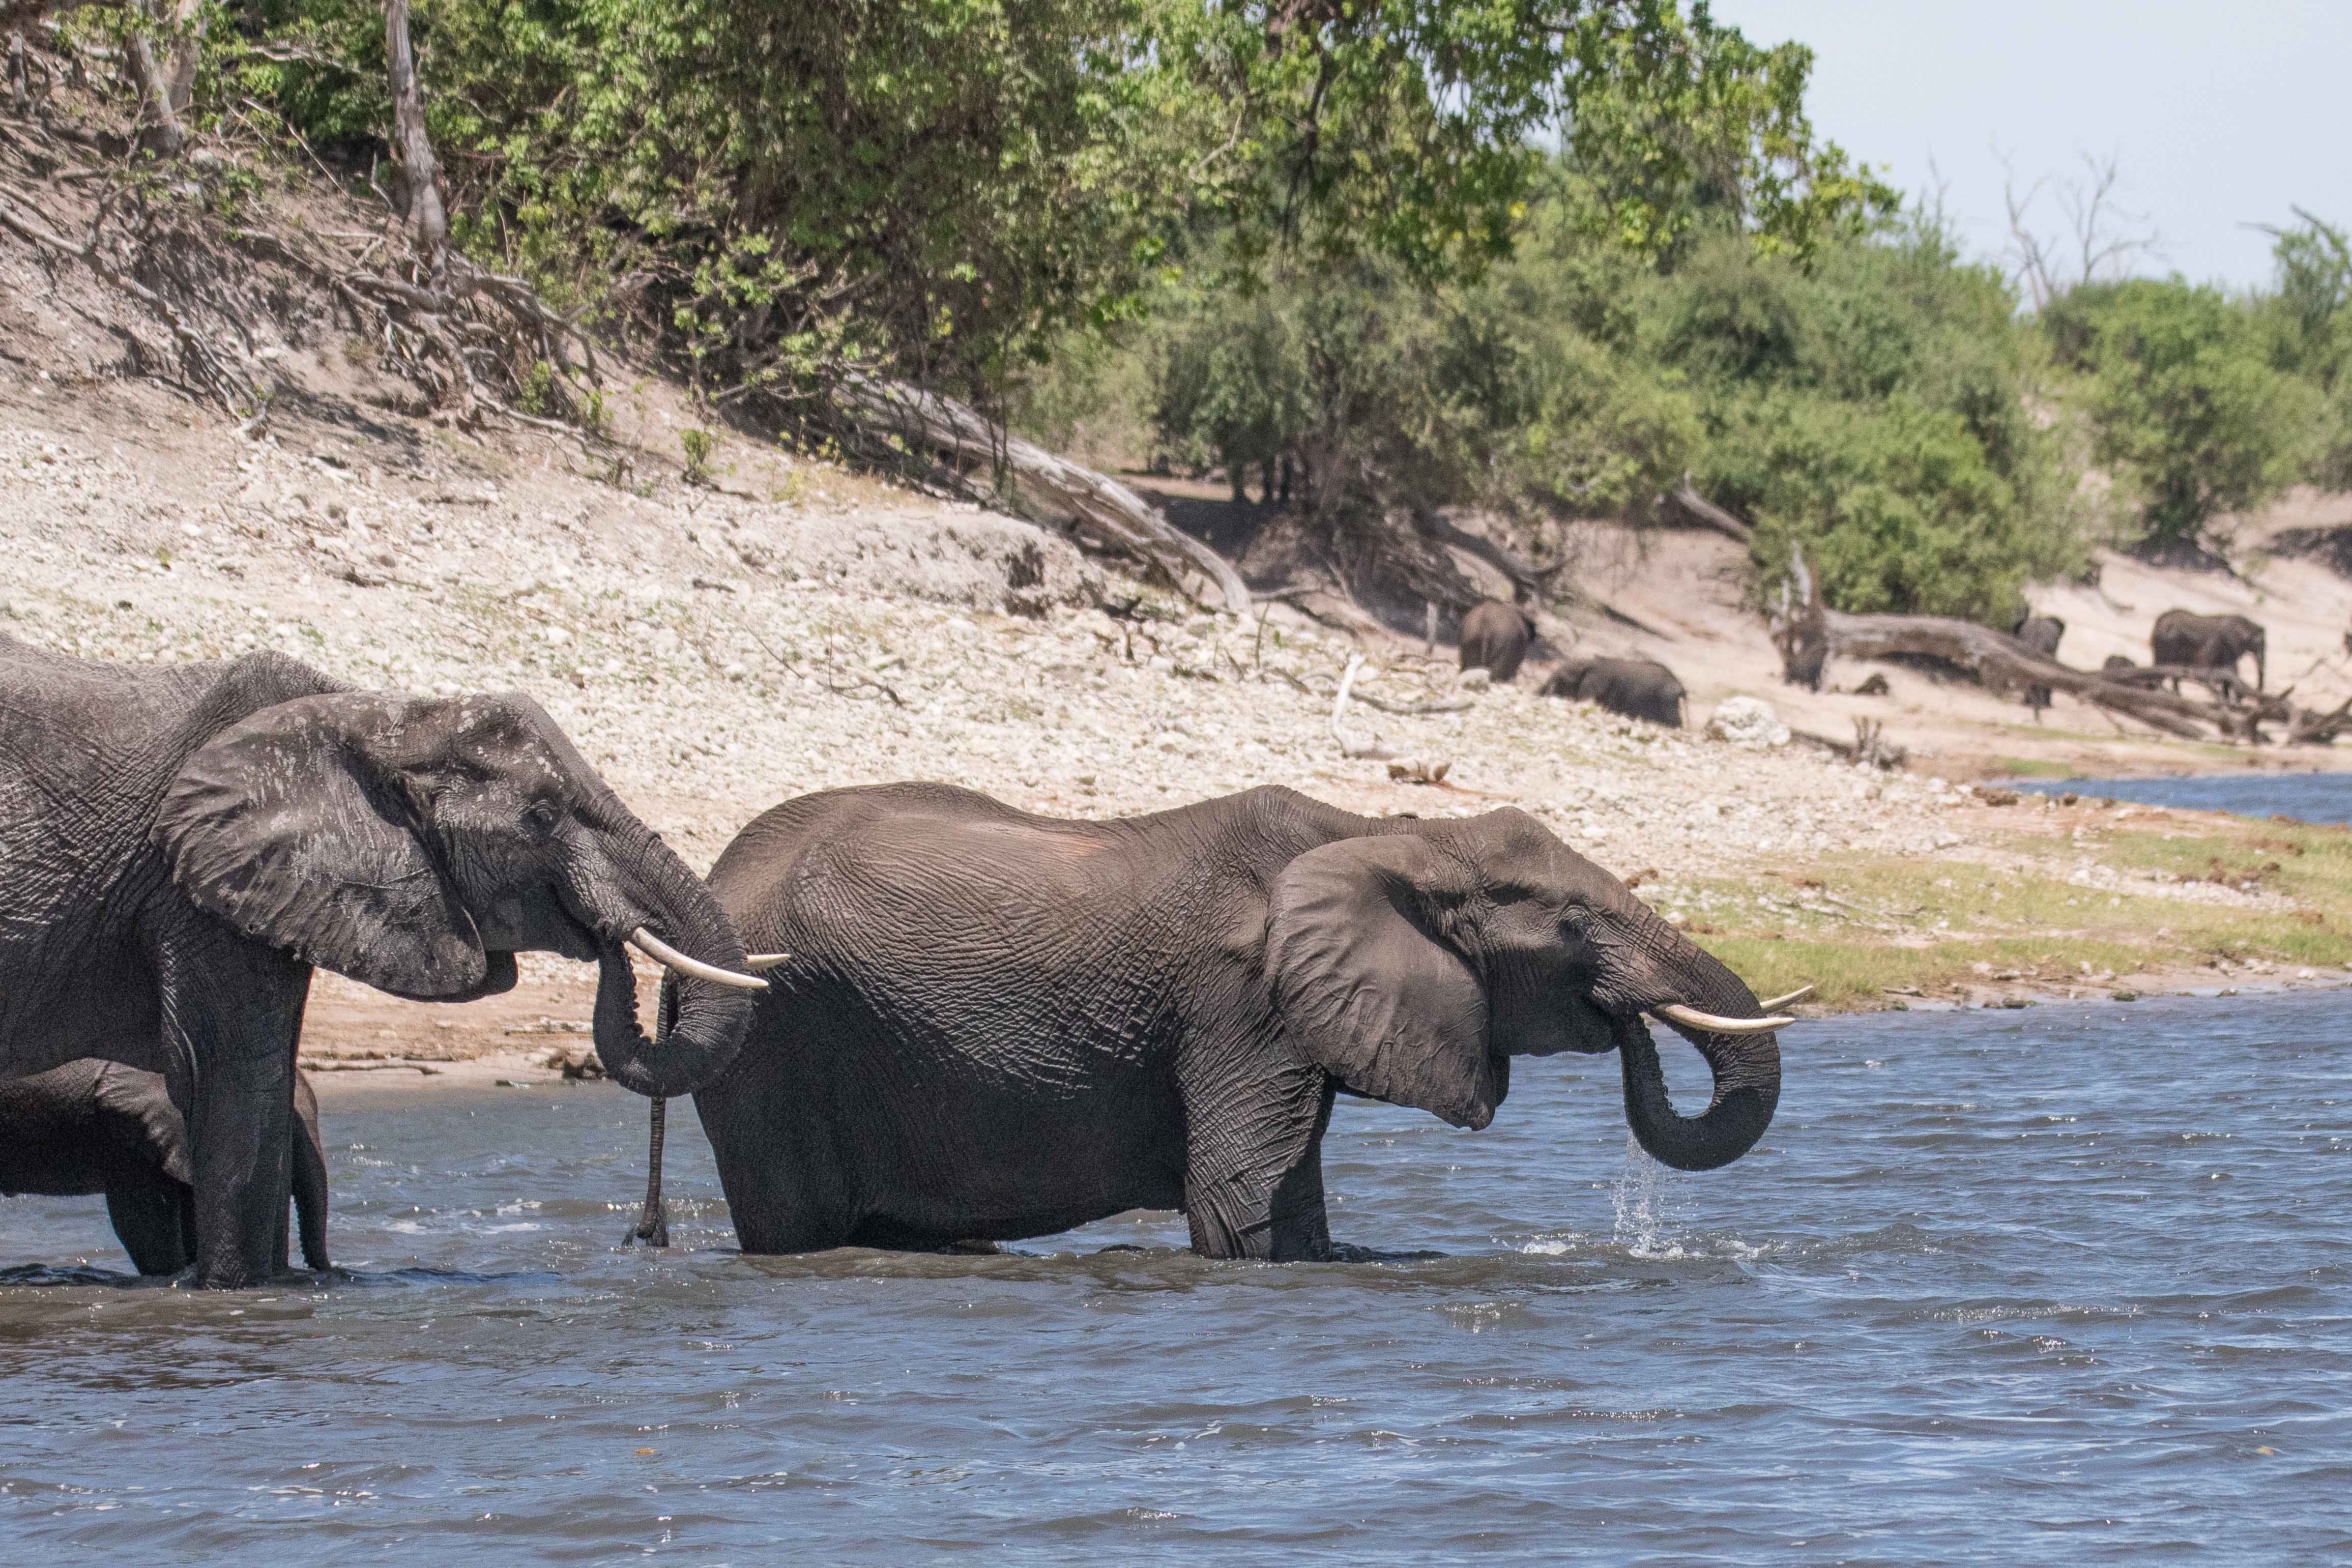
[{"xmin": 1774, "ymin": 550, "xmax": 2352, "ymax": 745}]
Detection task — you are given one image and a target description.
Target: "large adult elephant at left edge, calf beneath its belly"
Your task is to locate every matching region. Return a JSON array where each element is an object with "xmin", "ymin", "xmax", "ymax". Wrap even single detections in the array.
[{"xmin": 0, "ymin": 637, "xmax": 750, "ymax": 1286}]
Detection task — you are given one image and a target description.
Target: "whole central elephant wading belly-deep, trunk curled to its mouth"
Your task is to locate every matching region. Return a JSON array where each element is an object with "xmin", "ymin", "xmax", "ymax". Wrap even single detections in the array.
[{"xmin": 694, "ymin": 785, "xmax": 1781, "ymax": 1260}]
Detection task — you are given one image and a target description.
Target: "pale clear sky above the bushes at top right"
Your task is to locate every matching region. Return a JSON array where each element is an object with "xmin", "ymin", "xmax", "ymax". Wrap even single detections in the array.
[{"xmin": 1715, "ymin": 0, "xmax": 2352, "ymax": 287}]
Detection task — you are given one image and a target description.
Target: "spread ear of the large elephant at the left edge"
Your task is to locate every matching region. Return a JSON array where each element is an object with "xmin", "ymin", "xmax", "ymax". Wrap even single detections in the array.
[{"xmin": 155, "ymin": 693, "xmax": 489, "ymax": 999}]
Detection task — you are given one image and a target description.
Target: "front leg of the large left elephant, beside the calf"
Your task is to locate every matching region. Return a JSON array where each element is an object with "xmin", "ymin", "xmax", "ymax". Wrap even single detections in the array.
[{"xmin": 155, "ymin": 928, "xmax": 310, "ymax": 1291}]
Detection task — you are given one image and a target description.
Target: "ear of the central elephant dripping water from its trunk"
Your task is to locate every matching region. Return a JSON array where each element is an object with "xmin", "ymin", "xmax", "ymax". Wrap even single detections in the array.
[{"xmin": 1265, "ymin": 837, "xmax": 1510, "ymax": 1126}]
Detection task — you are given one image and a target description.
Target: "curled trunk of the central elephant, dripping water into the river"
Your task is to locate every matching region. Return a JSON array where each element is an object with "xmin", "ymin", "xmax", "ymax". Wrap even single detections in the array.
[{"xmin": 1618, "ymin": 921, "xmax": 1781, "ymax": 1171}]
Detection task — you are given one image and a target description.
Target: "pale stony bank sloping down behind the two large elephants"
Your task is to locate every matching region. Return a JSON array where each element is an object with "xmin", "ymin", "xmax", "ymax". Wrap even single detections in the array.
[{"xmin": 0, "ymin": 381, "xmax": 2342, "ymax": 1077}]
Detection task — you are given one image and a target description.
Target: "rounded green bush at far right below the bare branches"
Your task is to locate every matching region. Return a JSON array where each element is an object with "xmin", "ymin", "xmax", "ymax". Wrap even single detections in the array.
[{"xmin": 2044, "ymin": 277, "xmax": 2319, "ymax": 543}]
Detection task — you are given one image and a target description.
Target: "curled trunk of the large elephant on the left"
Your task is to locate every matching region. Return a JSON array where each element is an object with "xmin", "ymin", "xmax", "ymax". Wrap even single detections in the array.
[{"xmin": 571, "ymin": 821, "xmax": 752, "ymax": 1098}]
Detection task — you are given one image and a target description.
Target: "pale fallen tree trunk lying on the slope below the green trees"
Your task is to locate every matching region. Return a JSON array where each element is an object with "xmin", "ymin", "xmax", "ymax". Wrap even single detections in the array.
[{"xmin": 837, "ymin": 376, "xmax": 1251, "ymax": 611}]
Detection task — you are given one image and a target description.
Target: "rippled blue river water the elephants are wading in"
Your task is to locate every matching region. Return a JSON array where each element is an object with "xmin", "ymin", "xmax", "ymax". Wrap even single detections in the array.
[{"xmin": 0, "ymin": 992, "xmax": 2352, "ymax": 1563}]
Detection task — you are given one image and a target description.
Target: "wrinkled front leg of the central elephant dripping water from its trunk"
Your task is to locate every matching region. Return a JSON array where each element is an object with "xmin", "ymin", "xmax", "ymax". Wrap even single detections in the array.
[{"xmin": 1178, "ymin": 1053, "xmax": 1333, "ymax": 1262}]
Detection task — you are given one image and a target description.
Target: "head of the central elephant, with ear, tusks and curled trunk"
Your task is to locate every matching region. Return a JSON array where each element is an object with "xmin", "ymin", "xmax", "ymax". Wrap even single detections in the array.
[{"xmin": 1268, "ymin": 811, "xmax": 1802, "ymax": 1171}]
